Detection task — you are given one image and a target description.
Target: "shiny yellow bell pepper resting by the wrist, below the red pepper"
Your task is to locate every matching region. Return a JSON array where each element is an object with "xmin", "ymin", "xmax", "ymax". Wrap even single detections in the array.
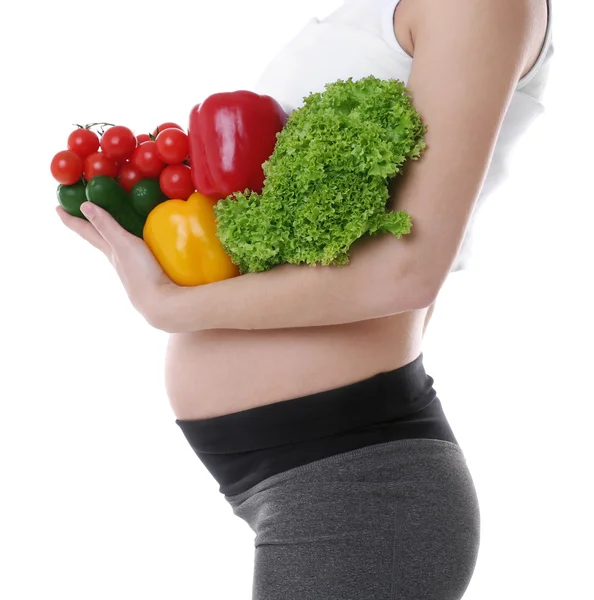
[{"xmin": 143, "ymin": 192, "xmax": 239, "ymax": 286}]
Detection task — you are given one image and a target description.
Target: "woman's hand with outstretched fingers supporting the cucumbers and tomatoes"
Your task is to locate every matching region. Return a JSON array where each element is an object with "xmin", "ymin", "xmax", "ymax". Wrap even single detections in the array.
[{"xmin": 56, "ymin": 202, "xmax": 181, "ymax": 333}]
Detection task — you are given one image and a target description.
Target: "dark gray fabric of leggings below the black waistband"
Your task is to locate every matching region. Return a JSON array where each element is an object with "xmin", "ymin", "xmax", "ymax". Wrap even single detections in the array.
[{"xmin": 225, "ymin": 439, "xmax": 480, "ymax": 600}]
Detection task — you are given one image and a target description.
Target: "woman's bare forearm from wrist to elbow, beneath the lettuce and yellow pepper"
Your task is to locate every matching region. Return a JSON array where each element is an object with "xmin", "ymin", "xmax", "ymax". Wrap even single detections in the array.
[{"xmin": 168, "ymin": 234, "xmax": 422, "ymax": 331}]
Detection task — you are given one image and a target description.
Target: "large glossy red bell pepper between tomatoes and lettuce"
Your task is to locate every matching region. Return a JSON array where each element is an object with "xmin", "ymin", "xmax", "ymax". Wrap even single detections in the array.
[{"xmin": 188, "ymin": 90, "xmax": 287, "ymax": 199}]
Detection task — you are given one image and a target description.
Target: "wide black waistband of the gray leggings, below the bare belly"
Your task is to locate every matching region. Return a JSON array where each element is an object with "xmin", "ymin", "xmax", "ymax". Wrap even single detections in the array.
[{"xmin": 176, "ymin": 354, "xmax": 457, "ymax": 496}]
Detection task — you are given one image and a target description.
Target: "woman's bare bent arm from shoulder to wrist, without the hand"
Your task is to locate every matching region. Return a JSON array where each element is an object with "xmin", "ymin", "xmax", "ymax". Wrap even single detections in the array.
[{"xmin": 166, "ymin": 0, "xmax": 535, "ymax": 331}]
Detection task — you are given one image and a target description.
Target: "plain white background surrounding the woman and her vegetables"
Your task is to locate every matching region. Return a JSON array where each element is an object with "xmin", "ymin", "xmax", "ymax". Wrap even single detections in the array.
[{"xmin": 0, "ymin": 0, "xmax": 594, "ymax": 600}]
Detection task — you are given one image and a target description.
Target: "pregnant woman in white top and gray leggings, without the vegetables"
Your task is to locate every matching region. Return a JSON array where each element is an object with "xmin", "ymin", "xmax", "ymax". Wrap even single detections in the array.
[{"xmin": 58, "ymin": 0, "xmax": 553, "ymax": 600}]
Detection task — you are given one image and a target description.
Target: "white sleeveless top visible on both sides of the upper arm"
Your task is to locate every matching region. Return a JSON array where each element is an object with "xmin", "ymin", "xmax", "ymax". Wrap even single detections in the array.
[{"xmin": 253, "ymin": 0, "xmax": 553, "ymax": 271}]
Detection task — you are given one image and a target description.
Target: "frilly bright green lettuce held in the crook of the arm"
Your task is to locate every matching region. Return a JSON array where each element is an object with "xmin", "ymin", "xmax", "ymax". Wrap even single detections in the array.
[{"xmin": 214, "ymin": 76, "xmax": 426, "ymax": 274}]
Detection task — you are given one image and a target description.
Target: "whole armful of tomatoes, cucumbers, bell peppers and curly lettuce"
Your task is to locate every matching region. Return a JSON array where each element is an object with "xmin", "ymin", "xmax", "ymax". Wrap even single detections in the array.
[{"xmin": 51, "ymin": 76, "xmax": 426, "ymax": 286}]
